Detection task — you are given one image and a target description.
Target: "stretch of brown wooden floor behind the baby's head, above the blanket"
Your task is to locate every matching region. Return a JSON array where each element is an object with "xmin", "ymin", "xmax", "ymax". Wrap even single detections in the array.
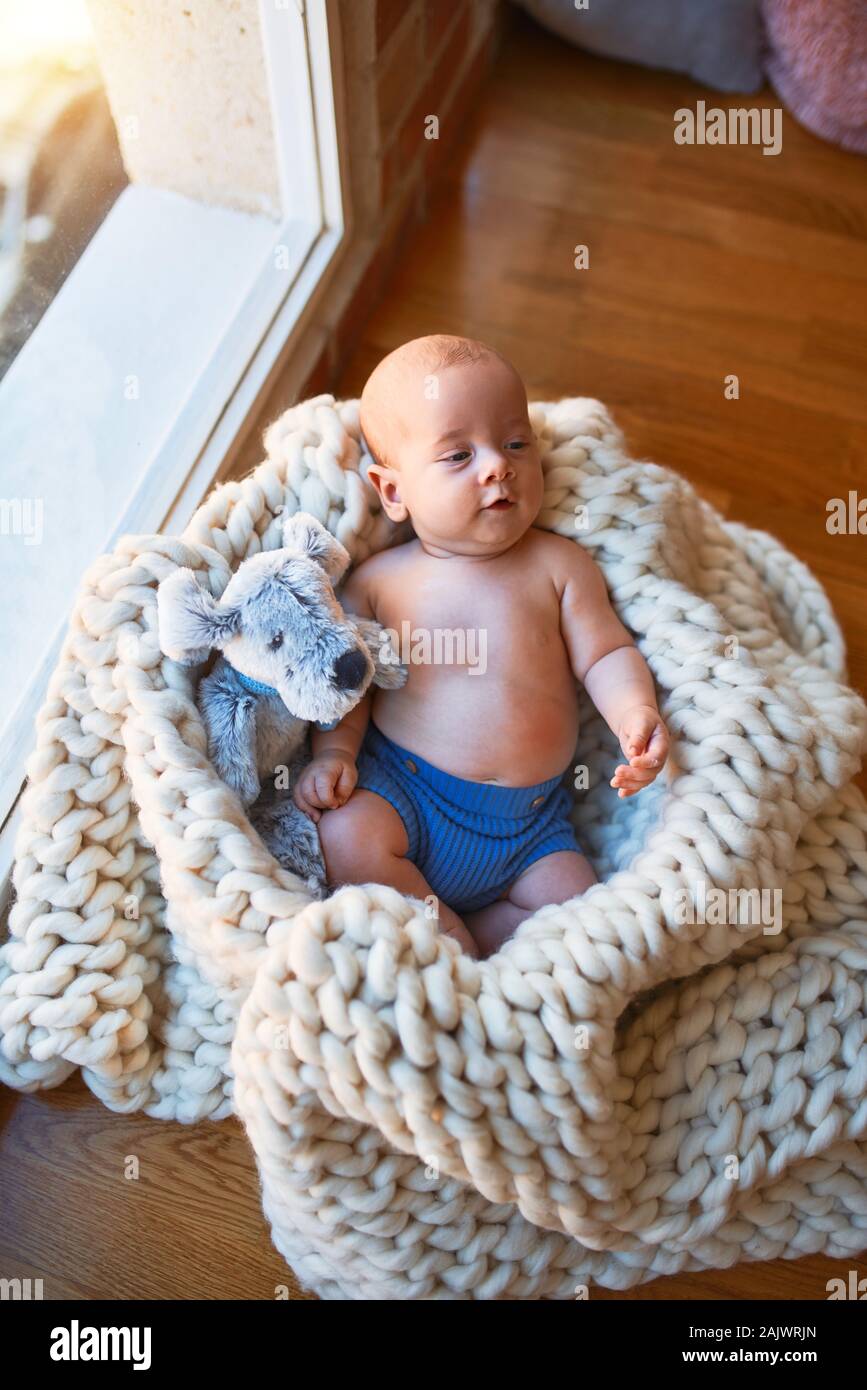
[{"xmin": 338, "ymin": 17, "xmax": 867, "ymax": 706}]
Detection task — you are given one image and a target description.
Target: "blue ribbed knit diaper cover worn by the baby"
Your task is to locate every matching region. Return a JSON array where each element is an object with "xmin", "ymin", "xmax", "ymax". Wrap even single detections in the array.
[{"xmin": 356, "ymin": 720, "xmax": 581, "ymax": 913}]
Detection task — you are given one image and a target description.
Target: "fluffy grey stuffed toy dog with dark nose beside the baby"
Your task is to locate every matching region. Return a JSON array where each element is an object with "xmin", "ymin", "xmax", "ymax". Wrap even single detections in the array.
[{"xmin": 157, "ymin": 512, "xmax": 407, "ymax": 897}]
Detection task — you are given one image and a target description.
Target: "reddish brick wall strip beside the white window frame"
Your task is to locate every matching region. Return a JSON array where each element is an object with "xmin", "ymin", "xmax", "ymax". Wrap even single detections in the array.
[{"xmin": 240, "ymin": 0, "xmax": 502, "ymax": 450}]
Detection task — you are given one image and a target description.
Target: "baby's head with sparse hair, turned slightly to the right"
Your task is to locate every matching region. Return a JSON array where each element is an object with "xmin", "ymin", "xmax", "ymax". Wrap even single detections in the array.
[{"xmin": 361, "ymin": 334, "xmax": 543, "ymax": 555}]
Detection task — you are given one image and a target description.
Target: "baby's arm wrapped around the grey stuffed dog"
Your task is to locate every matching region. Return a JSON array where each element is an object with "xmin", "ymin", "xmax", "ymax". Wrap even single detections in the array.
[{"xmin": 293, "ymin": 562, "xmax": 374, "ymax": 820}]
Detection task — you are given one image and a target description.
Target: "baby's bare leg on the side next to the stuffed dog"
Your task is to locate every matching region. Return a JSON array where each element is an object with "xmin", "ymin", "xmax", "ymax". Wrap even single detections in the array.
[{"xmin": 318, "ymin": 787, "xmax": 478, "ymax": 956}]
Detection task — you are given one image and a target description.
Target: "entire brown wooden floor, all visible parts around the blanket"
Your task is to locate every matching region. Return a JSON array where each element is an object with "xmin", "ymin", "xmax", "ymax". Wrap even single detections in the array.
[{"xmin": 0, "ymin": 5, "xmax": 867, "ymax": 1300}]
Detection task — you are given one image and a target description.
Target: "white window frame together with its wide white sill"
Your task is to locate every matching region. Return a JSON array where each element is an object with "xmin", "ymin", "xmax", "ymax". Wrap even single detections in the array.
[{"xmin": 0, "ymin": 0, "xmax": 352, "ymax": 874}]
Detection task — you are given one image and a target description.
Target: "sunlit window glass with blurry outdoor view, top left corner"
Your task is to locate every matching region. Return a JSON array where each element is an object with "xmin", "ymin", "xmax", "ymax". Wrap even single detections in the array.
[{"xmin": 0, "ymin": 0, "xmax": 128, "ymax": 378}]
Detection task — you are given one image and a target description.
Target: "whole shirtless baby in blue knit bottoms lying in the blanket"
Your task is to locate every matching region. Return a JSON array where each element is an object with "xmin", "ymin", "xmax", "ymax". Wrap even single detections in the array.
[{"xmin": 295, "ymin": 334, "xmax": 668, "ymax": 956}]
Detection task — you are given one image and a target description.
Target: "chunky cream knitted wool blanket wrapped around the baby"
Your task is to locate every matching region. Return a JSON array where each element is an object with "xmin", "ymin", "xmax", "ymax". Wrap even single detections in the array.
[{"xmin": 0, "ymin": 396, "xmax": 867, "ymax": 1298}]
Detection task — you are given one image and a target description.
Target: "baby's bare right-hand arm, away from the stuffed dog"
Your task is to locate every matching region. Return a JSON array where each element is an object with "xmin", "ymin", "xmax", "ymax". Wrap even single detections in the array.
[{"xmin": 560, "ymin": 542, "xmax": 668, "ymax": 796}]
